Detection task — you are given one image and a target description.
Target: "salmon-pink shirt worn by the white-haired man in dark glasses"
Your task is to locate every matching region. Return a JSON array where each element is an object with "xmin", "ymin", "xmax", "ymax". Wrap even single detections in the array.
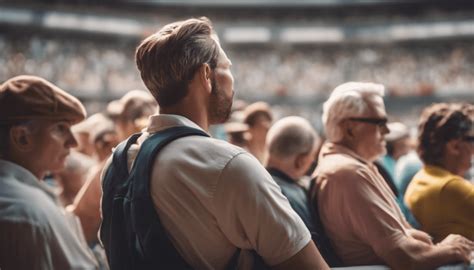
[{"xmin": 312, "ymin": 143, "xmax": 410, "ymax": 265}]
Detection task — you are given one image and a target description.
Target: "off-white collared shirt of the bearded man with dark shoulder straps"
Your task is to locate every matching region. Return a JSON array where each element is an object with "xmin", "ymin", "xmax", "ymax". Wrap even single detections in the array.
[{"xmin": 121, "ymin": 115, "xmax": 311, "ymax": 269}]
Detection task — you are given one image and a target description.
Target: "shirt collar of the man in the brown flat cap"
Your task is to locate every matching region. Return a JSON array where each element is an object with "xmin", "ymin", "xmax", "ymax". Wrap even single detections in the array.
[{"xmin": 0, "ymin": 159, "xmax": 57, "ymax": 201}]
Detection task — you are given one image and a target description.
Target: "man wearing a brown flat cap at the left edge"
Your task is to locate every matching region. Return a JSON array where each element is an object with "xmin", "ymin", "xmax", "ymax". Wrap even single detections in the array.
[{"xmin": 0, "ymin": 76, "xmax": 97, "ymax": 269}]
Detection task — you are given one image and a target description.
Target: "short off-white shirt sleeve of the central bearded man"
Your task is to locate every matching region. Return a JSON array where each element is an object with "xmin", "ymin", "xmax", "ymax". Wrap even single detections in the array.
[{"xmin": 214, "ymin": 153, "xmax": 311, "ymax": 265}]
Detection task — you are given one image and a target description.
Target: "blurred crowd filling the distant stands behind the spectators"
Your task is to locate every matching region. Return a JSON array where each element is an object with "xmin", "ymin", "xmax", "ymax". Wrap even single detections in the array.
[{"xmin": 0, "ymin": 36, "xmax": 474, "ymax": 100}]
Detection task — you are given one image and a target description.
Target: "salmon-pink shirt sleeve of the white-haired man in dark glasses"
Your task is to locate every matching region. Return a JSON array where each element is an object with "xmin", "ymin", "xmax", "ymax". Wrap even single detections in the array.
[{"xmin": 340, "ymin": 168, "xmax": 406, "ymax": 258}]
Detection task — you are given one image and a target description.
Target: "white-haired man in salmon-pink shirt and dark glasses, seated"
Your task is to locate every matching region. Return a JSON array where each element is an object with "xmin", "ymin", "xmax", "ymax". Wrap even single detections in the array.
[{"xmin": 310, "ymin": 82, "xmax": 474, "ymax": 269}]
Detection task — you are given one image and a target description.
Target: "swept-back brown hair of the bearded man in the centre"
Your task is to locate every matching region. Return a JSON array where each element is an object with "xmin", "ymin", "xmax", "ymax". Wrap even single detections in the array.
[{"xmin": 135, "ymin": 17, "xmax": 219, "ymax": 107}]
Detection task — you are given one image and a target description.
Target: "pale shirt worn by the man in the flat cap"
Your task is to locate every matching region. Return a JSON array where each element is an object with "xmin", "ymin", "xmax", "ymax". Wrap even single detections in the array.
[{"xmin": 0, "ymin": 160, "xmax": 97, "ymax": 270}]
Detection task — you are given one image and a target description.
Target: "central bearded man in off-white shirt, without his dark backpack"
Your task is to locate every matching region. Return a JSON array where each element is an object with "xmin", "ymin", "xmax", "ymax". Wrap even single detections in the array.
[{"xmin": 101, "ymin": 18, "xmax": 327, "ymax": 269}]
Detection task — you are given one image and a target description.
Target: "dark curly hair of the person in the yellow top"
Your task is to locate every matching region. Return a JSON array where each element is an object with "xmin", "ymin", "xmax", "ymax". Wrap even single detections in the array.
[{"xmin": 417, "ymin": 103, "xmax": 474, "ymax": 165}]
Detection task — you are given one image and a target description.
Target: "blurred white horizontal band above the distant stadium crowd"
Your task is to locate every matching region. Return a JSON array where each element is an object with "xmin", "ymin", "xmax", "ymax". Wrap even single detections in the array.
[{"xmin": 0, "ymin": 5, "xmax": 474, "ymax": 44}]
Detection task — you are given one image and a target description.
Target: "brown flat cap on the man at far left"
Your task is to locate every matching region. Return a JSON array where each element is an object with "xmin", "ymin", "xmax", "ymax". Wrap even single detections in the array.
[{"xmin": 0, "ymin": 75, "xmax": 86, "ymax": 123}]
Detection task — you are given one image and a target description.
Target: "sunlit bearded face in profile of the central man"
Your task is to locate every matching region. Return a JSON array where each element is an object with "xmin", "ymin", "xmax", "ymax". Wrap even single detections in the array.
[{"xmin": 209, "ymin": 40, "xmax": 234, "ymax": 124}]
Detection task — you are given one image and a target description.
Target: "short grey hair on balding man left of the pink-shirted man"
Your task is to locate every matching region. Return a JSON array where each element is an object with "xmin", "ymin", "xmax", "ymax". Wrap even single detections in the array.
[{"xmin": 266, "ymin": 116, "xmax": 319, "ymax": 159}]
